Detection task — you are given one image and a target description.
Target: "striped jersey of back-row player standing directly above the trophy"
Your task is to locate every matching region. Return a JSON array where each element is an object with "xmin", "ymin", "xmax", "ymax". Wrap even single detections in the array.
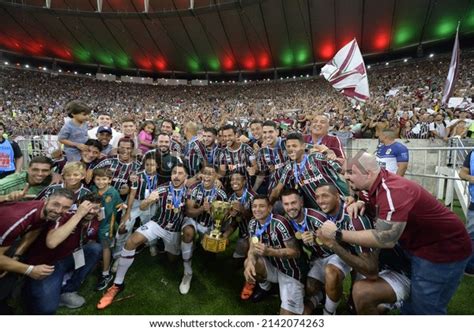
[{"xmin": 220, "ymin": 143, "xmax": 256, "ymax": 179}]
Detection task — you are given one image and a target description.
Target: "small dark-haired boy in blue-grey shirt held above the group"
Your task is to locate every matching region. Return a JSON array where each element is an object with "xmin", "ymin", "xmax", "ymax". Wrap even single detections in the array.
[{"xmin": 58, "ymin": 100, "xmax": 91, "ymax": 162}]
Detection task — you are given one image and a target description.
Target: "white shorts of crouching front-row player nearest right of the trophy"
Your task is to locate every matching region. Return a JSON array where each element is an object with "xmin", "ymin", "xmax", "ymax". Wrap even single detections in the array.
[{"xmin": 263, "ymin": 258, "xmax": 304, "ymax": 315}]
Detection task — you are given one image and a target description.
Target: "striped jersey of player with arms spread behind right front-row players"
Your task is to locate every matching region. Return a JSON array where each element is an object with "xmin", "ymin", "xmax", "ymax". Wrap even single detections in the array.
[{"xmin": 280, "ymin": 153, "xmax": 349, "ymax": 209}]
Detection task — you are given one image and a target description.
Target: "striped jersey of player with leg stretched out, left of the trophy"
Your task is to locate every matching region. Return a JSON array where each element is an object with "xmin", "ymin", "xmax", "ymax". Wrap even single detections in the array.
[{"xmin": 152, "ymin": 182, "xmax": 187, "ymax": 232}]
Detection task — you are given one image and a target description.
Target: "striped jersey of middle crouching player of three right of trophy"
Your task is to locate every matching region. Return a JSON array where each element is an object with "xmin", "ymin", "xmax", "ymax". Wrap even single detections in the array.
[{"xmin": 290, "ymin": 208, "xmax": 334, "ymax": 260}]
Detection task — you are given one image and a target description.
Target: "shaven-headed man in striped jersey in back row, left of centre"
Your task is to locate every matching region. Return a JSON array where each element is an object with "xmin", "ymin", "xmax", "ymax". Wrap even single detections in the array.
[{"xmin": 183, "ymin": 122, "xmax": 207, "ymax": 177}]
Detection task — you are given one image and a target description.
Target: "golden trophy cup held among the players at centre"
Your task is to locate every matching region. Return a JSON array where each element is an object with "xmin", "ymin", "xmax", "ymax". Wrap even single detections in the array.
[{"xmin": 202, "ymin": 201, "xmax": 231, "ymax": 253}]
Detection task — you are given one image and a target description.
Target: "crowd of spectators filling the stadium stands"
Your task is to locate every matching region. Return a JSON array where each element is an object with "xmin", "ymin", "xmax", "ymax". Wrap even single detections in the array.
[{"xmin": 0, "ymin": 52, "xmax": 474, "ymax": 139}]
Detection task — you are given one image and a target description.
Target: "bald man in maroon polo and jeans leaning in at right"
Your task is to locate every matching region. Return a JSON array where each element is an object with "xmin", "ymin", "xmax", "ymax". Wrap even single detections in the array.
[{"xmin": 321, "ymin": 153, "xmax": 472, "ymax": 315}]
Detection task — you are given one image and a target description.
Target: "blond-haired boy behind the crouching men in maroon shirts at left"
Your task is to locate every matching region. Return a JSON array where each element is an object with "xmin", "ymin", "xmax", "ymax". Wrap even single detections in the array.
[{"xmin": 35, "ymin": 162, "xmax": 91, "ymax": 211}]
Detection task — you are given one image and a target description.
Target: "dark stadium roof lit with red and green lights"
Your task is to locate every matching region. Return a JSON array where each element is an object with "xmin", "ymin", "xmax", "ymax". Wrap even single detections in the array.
[{"xmin": 0, "ymin": 0, "xmax": 474, "ymax": 73}]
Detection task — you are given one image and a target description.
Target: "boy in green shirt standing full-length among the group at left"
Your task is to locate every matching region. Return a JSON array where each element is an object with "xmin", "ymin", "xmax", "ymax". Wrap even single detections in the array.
[{"xmin": 92, "ymin": 168, "xmax": 123, "ymax": 291}]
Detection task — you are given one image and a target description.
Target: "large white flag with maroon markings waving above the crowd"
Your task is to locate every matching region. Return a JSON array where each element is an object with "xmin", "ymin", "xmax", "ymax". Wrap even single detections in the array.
[{"xmin": 321, "ymin": 39, "xmax": 369, "ymax": 102}]
